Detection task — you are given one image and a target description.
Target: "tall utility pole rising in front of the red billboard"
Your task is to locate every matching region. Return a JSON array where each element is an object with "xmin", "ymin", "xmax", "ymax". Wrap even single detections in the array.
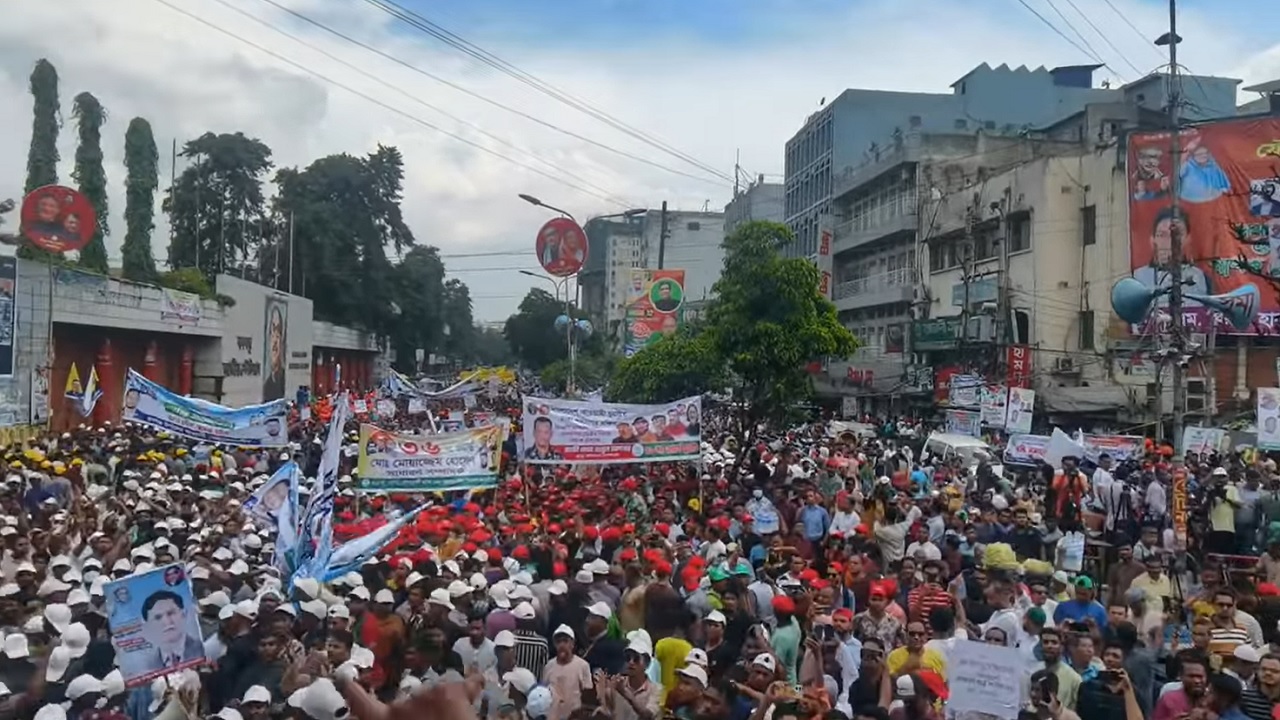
[{"xmin": 1157, "ymin": 0, "xmax": 1182, "ymax": 447}]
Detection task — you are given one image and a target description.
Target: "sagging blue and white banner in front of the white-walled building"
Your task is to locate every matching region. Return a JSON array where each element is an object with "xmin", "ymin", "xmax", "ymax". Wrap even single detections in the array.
[{"xmin": 120, "ymin": 369, "xmax": 289, "ymax": 447}]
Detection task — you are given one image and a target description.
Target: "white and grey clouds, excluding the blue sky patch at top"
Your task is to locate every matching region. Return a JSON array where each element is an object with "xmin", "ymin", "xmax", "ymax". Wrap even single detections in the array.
[{"xmin": 0, "ymin": 0, "xmax": 1280, "ymax": 319}]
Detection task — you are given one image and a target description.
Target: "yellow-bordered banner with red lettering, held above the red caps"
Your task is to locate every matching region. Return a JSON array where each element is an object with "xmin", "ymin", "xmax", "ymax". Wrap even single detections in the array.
[{"xmin": 358, "ymin": 423, "xmax": 507, "ymax": 492}]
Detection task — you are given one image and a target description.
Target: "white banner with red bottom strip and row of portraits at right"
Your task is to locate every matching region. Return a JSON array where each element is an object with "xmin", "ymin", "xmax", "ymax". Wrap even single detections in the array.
[{"xmin": 521, "ymin": 397, "xmax": 703, "ymax": 465}]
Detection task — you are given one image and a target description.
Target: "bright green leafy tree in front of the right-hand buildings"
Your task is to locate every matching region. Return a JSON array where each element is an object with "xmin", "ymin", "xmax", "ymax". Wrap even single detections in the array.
[{"xmin": 711, "ymin": 220, "xmax": 858, "ymax": 428}]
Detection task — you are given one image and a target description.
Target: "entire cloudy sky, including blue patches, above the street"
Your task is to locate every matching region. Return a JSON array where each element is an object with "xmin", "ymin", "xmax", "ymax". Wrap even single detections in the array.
[{"xmin": 0, "ymin": 0, "xmax": 1280, "ymax": 320}]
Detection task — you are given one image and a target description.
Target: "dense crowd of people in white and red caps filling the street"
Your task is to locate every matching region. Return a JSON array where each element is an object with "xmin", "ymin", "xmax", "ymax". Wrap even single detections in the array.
[{"xmin": 0, "ymin": 404, "xmax": 1280, "ymax": 720}]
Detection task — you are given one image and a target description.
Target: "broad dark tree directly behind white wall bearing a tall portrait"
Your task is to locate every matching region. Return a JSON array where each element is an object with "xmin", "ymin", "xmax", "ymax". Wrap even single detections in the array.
[{"xmin": 275, "ymin": 146, "xmax": 415, "ymax": 334}]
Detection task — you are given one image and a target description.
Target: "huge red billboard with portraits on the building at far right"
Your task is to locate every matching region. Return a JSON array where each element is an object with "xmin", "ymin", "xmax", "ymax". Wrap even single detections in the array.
[{"xmin": 1128, "ymin": 118, "xmax": 1280, "ymax": 334}]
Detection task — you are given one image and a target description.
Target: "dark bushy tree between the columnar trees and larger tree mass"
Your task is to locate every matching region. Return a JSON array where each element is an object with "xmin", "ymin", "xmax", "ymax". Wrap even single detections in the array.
[{"xmin": 163, "ymin": 132, "xmax": 271, "ymax": 284}]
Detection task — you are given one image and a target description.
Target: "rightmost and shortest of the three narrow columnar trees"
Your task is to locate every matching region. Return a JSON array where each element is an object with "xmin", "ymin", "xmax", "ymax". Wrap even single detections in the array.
[{"xmin": 122, "ymin": 118, "xmax": 160, "ymax": 283}]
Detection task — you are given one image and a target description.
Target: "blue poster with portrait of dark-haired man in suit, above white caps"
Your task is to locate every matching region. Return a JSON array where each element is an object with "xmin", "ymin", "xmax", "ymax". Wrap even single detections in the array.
[{"xmin": 102, "ymin": 564, "xmax": 205, "ymax": 687}]
